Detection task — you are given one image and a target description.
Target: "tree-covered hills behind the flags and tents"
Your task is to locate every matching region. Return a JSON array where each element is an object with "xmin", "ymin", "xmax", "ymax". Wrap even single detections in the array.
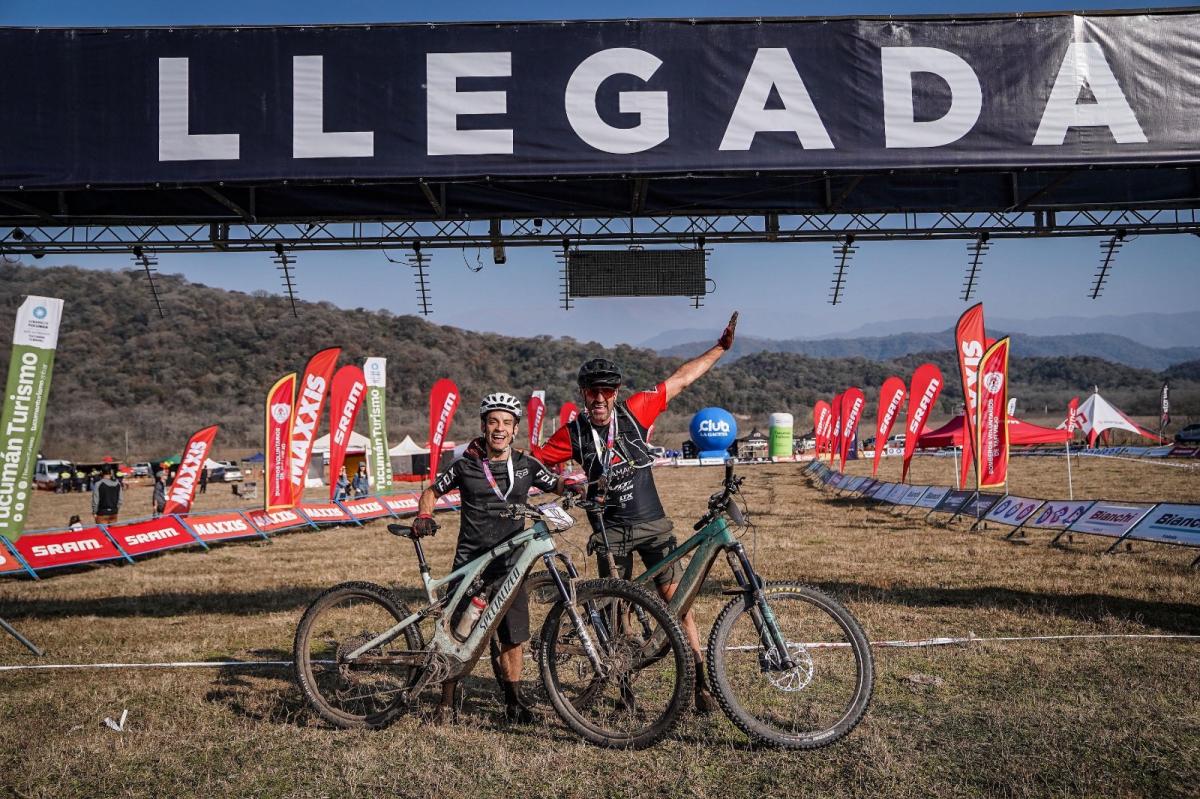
[{"xmin": 0, "ymin": 264, "xmax": 1200, "ymax": 459}]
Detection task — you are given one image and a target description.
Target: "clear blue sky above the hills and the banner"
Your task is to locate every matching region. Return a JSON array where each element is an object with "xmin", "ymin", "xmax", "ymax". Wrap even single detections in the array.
[{"xmin": 9, "ymin": 0, "xmax": 1200, "ymax": 343}]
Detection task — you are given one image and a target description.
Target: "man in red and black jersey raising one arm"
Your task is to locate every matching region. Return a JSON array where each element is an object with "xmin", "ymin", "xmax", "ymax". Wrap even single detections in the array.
[{"xmin": 534, "ymin": 312, "xmax": 738, "ymax": 713}]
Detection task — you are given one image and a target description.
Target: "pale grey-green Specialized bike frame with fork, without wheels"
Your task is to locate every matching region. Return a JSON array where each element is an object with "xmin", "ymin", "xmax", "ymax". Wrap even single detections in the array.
[{"xmin": 346, "ymin": 513, "xmax": 602, "ymax": 677}]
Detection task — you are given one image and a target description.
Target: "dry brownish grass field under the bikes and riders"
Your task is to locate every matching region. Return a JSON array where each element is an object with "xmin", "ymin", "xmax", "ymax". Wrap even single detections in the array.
[{"xmin": 0, "ymin": 458, "xmax": 1200, "ymax": 797}]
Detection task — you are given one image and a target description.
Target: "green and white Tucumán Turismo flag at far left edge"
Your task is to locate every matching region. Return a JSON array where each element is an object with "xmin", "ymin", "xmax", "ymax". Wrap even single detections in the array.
[{"xmin": 0, "ymin": 295, "xmax": 62, "ymax": 541}]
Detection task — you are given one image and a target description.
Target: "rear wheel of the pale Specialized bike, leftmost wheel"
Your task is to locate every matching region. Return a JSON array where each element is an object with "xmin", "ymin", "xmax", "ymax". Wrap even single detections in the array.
[{"xmin": 293, "ymin": 582, "xmax": 424, "ymax": 729}]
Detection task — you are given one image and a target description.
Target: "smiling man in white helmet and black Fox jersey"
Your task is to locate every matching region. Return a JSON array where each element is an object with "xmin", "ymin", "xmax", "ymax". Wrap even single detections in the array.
[{"xmin": 413, "ymin": 392, "xmax": 563, "ymax": 723}]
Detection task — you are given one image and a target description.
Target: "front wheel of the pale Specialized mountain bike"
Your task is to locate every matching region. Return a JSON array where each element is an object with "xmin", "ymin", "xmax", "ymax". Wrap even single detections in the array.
[{"xmin": 540, "ymin": 579, "xmax": 695, "ymax": 749}]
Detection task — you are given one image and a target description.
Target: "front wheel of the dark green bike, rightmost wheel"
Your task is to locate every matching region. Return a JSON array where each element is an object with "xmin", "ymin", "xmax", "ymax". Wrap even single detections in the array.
[{"xmin": 708, "ymin": 583, "xmax": 875, "ymax": 749}]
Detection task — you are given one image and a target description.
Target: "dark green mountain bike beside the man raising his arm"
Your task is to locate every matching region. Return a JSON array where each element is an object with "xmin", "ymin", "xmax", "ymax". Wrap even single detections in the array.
[{"xmin": 529, "ymin": 464, "xmax": 875, "ymax": 749}]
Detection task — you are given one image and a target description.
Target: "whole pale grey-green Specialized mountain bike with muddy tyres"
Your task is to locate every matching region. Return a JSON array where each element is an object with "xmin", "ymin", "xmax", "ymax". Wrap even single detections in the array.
[{"xmin": 293, "ymin": 494, "xmax": 695, "ymax": 749}]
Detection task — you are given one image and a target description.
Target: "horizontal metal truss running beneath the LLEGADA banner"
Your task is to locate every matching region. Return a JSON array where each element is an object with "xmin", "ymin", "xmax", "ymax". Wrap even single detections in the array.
[{"xmin": 0, "ymin": 209, "xmax": 1200, "ymax": 258}]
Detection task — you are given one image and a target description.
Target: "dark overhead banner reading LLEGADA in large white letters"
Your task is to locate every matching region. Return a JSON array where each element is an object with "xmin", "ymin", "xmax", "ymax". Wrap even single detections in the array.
[{"xmin": 0, "ymin": 10, "xmax": 1200, "ymax": 190}]
